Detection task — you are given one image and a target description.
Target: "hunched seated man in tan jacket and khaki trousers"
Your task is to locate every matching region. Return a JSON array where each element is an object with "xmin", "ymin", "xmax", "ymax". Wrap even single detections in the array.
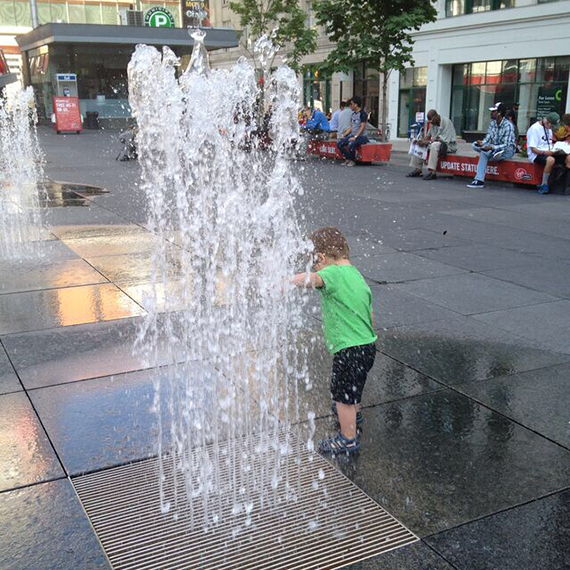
[{"xmin": 406, "ymin": 109, "xmax": 457, "ymax": 180}]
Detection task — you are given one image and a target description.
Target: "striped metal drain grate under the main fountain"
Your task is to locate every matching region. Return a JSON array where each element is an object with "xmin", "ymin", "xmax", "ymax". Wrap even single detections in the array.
[{"xmin": 72, "ymin": 444, "xmax": 418, "ymax": 570}]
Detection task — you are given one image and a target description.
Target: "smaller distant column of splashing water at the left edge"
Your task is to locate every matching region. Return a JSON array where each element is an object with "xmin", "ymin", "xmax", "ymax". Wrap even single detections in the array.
[{"xmin": 0, "ymin": 86, "xmax": 43, "ymax": 260}]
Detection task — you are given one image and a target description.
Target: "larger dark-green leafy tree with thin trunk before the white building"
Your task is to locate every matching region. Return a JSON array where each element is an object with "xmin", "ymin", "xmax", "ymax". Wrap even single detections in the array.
[{"xmin": 314, "ymin": 0, "xmax": 437, "ymax": 140}]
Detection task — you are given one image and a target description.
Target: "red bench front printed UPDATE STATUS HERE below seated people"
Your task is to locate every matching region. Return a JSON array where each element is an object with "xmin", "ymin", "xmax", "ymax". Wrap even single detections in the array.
[{"xmin": 437, "ymin": 154, "xmax": 544, "ymax": 186}]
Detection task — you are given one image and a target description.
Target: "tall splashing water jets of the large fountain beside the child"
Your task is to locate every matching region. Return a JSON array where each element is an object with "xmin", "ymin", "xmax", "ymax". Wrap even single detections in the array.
[{"xmin": 128, "ymin": 32, "xmax": 308, "ymax": 536}]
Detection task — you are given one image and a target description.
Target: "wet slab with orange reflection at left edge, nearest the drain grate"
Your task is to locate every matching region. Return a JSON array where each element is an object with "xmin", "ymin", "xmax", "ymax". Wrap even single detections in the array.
[{"xmin": 0, "ymin": 392, "xmax": 64, "ymax": 488}]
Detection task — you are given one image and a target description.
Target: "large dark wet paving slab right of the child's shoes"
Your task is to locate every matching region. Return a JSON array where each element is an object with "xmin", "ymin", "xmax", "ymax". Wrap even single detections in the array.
[{"xmin": 308, "ymin": 390, "xmax": 570, "ymax": 537}]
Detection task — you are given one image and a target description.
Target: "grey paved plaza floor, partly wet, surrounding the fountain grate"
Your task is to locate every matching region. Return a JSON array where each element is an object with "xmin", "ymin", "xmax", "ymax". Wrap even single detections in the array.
[{"xmin": 0, "ymin": 126, "xmax": 570, "ymax": 570}]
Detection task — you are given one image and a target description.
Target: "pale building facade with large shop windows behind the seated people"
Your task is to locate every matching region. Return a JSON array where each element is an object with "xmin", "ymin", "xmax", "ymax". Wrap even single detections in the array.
[{"xmin": 210, "ymin": 0, "xmax": 570, "ymax": 139}]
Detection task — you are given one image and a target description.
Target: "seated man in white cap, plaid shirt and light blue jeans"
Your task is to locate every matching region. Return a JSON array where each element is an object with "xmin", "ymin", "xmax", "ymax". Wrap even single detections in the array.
[{"xmin": 467, "ymin": 103, "xmax": 516, "ymax": 188}]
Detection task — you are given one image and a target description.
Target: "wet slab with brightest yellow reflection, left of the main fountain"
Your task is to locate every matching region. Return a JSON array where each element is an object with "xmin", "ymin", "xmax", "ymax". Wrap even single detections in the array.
[{"xmin": 0, "ymin": 283, "xmax": 145, "ymax": 335}]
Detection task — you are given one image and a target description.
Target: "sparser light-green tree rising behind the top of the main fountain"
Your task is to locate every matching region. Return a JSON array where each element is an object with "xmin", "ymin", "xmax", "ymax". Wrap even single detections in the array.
[{"xmin": 230, "ymin": 0, "xmax": 317, "ymax": 70}]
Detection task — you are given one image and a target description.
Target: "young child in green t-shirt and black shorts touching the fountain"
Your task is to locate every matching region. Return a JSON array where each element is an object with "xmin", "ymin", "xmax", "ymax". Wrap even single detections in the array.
[{"xmin": 292, "ymin": 227, "xmax": 378, "ymax": 455}]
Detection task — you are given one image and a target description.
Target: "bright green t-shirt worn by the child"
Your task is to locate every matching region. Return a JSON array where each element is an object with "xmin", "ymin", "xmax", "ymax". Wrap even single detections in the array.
[{"xmin": 317, "ymin": 265, "xmax": 378, "ymax": 354}]
